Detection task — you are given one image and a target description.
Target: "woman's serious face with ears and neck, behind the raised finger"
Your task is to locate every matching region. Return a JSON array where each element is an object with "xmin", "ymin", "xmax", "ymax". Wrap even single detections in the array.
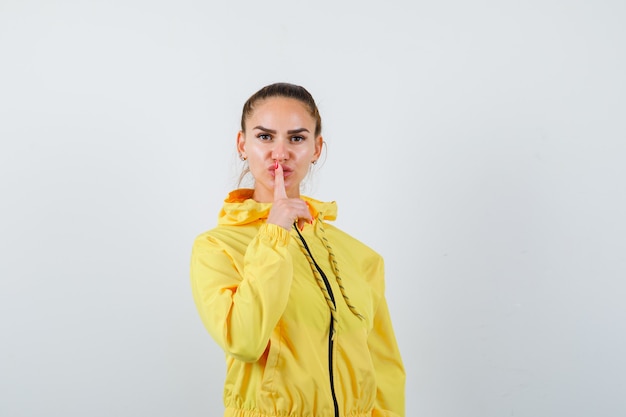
[{"xmin": 237, "ymin": 97, "xmax": 323, "ymax": 203}]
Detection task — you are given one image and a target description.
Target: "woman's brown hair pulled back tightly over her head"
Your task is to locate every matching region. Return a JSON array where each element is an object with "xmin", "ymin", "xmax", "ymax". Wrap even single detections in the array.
[{"xmin": 241, "ymin": 83, "xmax": 322, "ymax": 137}]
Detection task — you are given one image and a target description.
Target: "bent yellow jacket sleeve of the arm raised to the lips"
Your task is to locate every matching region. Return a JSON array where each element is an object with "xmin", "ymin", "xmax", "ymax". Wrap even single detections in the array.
[{"xmin": 191, "ymin": 223, "xmax": 293, "ymax": 362}]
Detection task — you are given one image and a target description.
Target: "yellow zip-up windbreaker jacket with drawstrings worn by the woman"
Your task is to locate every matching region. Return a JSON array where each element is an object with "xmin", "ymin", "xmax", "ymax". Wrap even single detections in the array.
[{"xmin": 191, "ymin": 189, "xmax": 405, "ymax": 417}]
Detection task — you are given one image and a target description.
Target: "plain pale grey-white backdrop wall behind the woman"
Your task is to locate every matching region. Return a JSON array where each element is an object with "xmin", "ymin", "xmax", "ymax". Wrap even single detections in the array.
[{"xmin": 0, "ymin": 0, "xmax": 626, "ymax": 417}]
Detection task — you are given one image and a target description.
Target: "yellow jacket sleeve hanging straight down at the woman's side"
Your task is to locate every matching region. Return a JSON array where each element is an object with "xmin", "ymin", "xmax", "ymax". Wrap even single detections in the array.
[{"xmin": 368, "ymin": 265, "xmax": 406, "ymax": 417}]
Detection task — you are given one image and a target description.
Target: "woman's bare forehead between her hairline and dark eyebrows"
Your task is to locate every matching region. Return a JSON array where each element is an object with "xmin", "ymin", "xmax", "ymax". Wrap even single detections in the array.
[{"xmin": 248, "ymin": 97, "xmax": 315, "ymax": 127}]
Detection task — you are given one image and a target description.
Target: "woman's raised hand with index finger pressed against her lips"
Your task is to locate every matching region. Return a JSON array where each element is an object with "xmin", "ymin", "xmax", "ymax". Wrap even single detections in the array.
[{"xmin": 267, "ymin": 164, "xmax": 313, "ymax": 230}]
